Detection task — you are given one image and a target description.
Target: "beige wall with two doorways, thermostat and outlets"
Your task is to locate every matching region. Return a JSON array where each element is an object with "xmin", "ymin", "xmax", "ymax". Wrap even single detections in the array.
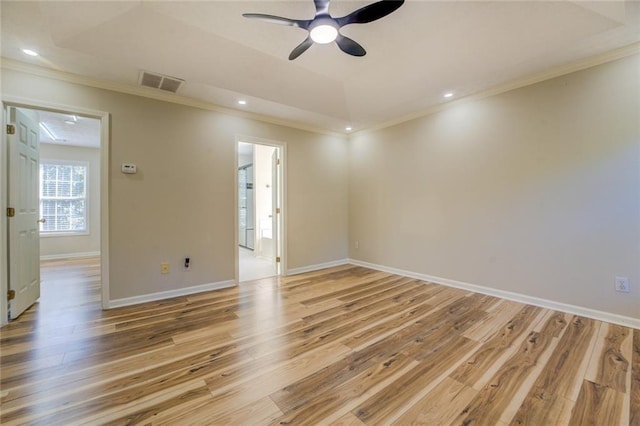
[{"xmin": 2, "ymin": 70, "xmax": 348, "ymax": 300}]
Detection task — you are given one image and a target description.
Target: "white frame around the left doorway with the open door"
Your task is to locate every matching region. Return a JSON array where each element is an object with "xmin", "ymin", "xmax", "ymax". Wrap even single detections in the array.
[{"xmin": 0, "ymin": 96, "xmax": 110, "ymax": 326}]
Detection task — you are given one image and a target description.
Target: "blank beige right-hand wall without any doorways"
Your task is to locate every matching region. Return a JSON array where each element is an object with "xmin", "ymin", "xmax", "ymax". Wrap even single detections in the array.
[{"xmin": 349, "ymin": 56, "xmax": 640, "ymax": 318}]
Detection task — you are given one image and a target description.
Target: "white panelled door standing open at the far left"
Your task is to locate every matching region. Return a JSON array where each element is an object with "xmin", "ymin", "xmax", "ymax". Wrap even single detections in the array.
[{"xmin": 7, "ymin": 108, "xmax": 40, "ymax": 319}]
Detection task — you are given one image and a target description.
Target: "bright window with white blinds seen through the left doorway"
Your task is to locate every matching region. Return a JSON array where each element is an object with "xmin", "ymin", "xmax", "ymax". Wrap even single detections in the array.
[{"xmin": 40, "ymin": 160, "xmax": 88, "ymax": 234}]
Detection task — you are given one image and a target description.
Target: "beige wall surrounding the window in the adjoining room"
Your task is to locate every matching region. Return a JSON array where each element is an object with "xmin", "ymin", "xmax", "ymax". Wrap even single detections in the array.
[{"xmin": 40, "ymin": 143, "xmax": 100, "ymax": 258}]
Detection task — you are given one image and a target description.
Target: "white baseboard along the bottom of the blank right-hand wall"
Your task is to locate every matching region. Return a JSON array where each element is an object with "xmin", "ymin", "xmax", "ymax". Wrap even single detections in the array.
[{"xmin": 349, "ymin": 259, "xmax": 640, "ymax": 329}]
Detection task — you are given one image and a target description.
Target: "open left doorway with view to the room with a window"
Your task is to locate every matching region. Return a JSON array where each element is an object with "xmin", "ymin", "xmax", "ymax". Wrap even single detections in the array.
[{"xmin": 2, "ymin": 106, "xmax": 106, "ymax": 322}]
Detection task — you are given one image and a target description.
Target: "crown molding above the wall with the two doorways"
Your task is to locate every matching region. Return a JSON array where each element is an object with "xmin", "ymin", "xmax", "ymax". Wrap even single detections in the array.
[{"xmin": 0, "ymin": 57, "xmax": 345, "ymax": 137}]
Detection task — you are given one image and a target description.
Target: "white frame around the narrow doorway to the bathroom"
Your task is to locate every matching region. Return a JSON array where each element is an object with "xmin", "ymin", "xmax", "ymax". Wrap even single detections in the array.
[{"xmin": 233, "ymin": 135, "xmax": 287, "ymax": 284}]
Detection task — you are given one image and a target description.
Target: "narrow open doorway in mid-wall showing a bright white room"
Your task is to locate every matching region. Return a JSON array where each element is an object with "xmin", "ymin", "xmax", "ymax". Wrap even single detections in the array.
[{"xmin": 237, "ymin": 141, "xmax": 282, "ymax": 282}]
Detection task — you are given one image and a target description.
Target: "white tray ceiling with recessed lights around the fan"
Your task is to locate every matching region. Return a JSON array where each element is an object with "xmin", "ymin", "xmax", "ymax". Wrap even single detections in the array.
[{"xmin": 1, "ymin": 0, "xmax": 640, "ymax": 132}]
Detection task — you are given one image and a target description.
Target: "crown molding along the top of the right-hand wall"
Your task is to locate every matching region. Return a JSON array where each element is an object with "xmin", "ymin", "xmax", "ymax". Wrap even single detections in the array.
[{"xmin": 360, "ymin": 42, "xmax": 640, "ymax": 135}]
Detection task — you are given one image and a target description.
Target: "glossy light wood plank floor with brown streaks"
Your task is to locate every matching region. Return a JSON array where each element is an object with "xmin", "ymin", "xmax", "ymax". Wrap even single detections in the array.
[{"xmin": 0, "ymin": 260, "xmax": 640, "ymax": 426}]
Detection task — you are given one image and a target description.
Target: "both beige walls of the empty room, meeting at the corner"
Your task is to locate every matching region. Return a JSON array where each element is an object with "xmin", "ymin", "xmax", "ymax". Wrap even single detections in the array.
[{"xmin": 2, "ymin": 56, "xmax": 640, "ymax": 318}]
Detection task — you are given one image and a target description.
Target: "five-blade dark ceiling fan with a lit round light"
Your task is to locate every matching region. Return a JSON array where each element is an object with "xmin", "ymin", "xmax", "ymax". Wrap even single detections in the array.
[{"xmin": 242, "ymin": 0, "xmax": 404, "ymax": 60}]
